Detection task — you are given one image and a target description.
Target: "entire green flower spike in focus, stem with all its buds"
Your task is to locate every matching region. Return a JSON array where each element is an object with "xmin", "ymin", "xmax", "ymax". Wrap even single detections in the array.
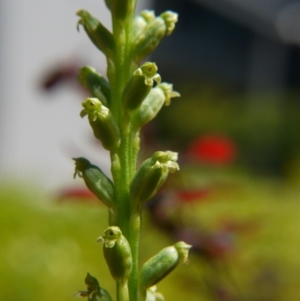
[{"xmin": 74, "ymin": 0, "xmax": 191, "ymax": 301}]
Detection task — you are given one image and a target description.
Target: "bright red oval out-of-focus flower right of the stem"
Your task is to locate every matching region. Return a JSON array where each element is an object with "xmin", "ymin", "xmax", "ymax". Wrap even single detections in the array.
[{"xmin": 187, "ymin": 135, "xmax": 237, "ymax": 164}]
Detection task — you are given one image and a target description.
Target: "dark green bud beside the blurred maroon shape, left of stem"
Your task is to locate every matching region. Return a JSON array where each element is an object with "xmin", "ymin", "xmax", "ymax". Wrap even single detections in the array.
[{"xmin": 77, "ymin": 66, "xmax": 110, "ymax": 106}]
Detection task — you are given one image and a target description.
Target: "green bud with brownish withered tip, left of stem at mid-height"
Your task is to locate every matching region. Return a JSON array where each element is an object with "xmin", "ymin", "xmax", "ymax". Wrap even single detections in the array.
[{"xmin": 73, "ymin": 158, "xmax": 115, "ymax": 208}]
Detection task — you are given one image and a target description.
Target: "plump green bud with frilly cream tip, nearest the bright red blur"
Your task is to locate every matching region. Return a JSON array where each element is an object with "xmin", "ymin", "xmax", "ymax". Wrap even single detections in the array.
[{"xmin": 130, "ymin": 151, "xmax": 179, "ymax": 207}]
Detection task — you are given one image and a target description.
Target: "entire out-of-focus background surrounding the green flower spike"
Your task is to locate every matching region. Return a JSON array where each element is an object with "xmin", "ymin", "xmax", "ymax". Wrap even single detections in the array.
[{"xmin": 0, "ymin": 0, "xmax": 300, "ymax": 301}]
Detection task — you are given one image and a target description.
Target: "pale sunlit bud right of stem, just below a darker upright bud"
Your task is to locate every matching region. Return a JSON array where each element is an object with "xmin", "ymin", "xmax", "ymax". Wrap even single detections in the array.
[{"xmin": 132, "ymin": 83, "xmax": 180, "ymax": 128}]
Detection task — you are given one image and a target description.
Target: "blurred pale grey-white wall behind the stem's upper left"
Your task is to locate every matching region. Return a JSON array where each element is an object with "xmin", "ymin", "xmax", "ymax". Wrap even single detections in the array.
[{"xmin": 0, "ymin": 0, "xmax": 150, "ymax": 188}]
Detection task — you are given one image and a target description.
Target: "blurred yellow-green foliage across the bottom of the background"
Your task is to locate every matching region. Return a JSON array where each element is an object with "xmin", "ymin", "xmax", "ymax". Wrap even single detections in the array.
[{"xmin": 0, "ymin": 171, "xmax": 300, "ymax": 301}]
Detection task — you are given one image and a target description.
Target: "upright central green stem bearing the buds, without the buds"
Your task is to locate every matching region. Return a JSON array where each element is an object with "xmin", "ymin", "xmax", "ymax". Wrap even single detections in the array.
[{"xmin": 107, "ymin": 0, "xmax": 140, "ymax": 301}]
